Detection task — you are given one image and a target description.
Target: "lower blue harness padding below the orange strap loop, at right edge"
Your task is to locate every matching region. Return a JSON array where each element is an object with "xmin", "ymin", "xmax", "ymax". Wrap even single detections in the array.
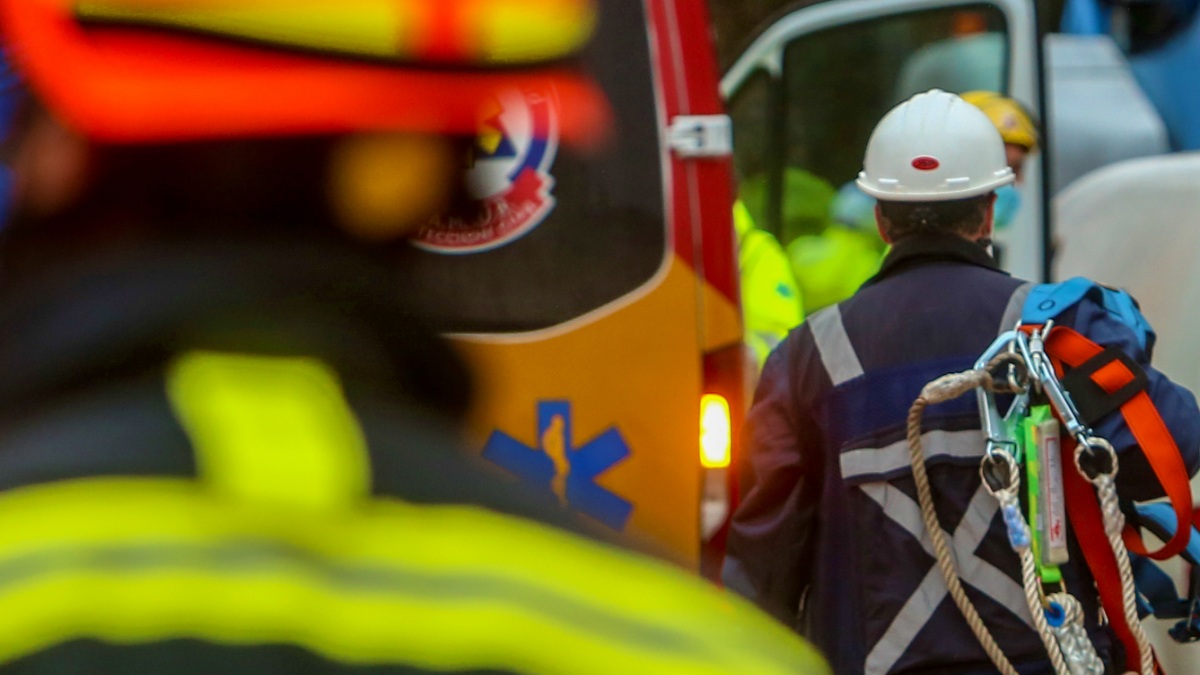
[{"xmin": 1129, "ymin": 502, "xmax": 1200, "ymax": 643}]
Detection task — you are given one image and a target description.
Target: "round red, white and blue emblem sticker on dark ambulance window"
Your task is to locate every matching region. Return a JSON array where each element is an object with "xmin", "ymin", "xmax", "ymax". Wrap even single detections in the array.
[{"xmin": 413, "ymin": 90, "xmax": 558, "ymax": 253}]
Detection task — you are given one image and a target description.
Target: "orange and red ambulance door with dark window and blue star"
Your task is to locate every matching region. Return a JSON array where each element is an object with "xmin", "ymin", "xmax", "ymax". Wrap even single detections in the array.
[{"xmin": 403, "ymin": 0, "xmax": 742, "ymax": 567}]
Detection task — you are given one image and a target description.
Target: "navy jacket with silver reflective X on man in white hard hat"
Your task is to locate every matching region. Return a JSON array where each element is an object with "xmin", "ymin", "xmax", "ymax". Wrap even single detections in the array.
[{"xmin": 722, "ymin": 235, "xmax": 1200, "ymax": 675}]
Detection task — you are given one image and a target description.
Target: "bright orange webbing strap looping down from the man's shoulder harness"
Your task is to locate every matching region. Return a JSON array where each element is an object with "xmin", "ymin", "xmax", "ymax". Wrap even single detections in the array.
[{"xmin": 1045, "ymin": 327, "xmax": 1192, "ymax": 560}]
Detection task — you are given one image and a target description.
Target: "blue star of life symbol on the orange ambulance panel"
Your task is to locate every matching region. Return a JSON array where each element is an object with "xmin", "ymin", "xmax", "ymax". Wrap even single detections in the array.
[{"xmin": 484, "ymin": 401, "xmax": 634, "ymax": 530}]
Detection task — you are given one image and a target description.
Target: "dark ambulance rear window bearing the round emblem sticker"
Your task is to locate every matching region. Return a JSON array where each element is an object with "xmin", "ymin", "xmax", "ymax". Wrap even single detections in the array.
[{"xmin": 398, "ymin": 0, "xmax": 667, "ymax": 333}]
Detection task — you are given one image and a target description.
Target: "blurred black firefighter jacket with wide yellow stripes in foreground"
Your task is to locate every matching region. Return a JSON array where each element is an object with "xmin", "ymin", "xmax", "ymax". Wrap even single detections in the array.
[{"xmin": 0, "ymin": 234, "xmax": 826, "ymax": 675}]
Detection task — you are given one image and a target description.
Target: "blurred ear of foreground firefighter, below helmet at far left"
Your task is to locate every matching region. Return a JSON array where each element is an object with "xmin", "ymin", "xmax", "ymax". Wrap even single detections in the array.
[{"xmin": 8, "ymin": 109, "xmax": 92, "ymax": 217}]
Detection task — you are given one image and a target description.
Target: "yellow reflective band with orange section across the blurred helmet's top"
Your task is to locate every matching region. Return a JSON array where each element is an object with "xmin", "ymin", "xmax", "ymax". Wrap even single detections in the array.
[{"xmin": 76, "ymin": 0, "xmax": 595, "ymax": 65}]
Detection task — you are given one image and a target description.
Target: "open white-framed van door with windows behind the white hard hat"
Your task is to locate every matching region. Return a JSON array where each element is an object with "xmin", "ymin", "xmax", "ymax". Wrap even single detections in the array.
[{"xmin": 721, "ymin": 0, "xmax": 1050, "ymax": 283}]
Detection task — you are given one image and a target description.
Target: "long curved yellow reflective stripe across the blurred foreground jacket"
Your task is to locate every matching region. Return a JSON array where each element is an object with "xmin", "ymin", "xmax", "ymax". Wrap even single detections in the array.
[{"xmin": 0, "ymin": 479, "xmax": 826, "ymax": 675}]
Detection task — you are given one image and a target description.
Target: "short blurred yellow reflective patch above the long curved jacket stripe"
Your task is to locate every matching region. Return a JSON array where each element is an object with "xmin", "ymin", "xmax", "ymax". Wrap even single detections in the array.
[{"xmin": 167, "ymin": 352, "xmax": 371, "ymax": 509}]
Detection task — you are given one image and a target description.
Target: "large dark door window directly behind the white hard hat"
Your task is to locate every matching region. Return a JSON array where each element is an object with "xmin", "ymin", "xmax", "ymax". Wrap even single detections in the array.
[{"xmin": 778, "ymin": 5, "xmax": 1008, "ymax": 245}]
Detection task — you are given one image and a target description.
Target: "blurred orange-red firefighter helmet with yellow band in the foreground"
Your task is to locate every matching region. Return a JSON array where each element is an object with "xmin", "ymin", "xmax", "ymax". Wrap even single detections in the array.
[{"xmin": 0, "ymin": 0, "xmax": 607, "ymax": 143}]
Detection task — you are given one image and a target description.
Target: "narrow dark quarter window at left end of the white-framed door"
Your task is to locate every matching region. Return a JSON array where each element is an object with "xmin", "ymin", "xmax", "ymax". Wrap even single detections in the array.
[{"xmin": 728, "ymin": 70, "xmax": 776, "ymax": 227}]
